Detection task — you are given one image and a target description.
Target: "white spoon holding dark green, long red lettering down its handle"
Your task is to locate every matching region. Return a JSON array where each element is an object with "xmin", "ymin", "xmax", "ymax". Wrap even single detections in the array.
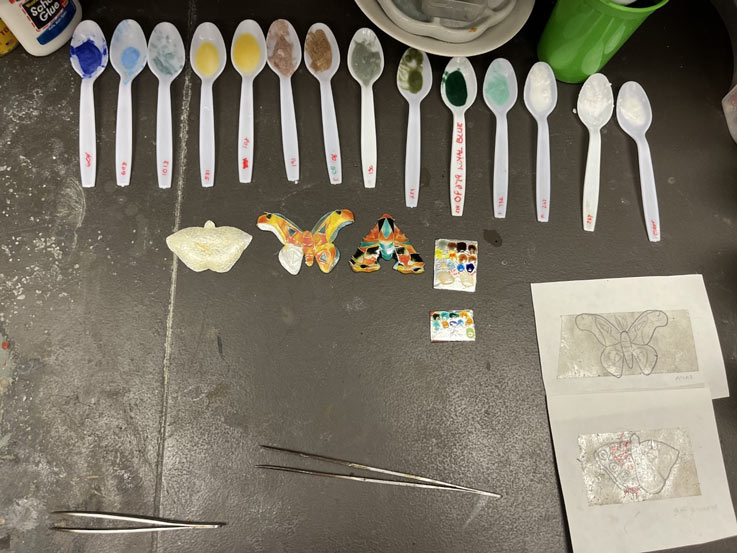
[{"xmin": 440, "ymin": 58, "xmax": 478, "ymax": 217}]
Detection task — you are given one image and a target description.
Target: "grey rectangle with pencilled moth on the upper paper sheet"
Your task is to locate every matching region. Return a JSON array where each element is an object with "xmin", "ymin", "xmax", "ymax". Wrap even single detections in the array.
[{"xmin": 558, "ymin": 309, "xmax": 698, "ymax": 378}]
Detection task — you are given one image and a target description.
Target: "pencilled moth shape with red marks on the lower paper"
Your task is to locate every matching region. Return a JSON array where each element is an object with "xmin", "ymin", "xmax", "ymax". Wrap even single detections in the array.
[{"xmin": 596, "ymin": 433, "xmax": 679, "ymax": 494}]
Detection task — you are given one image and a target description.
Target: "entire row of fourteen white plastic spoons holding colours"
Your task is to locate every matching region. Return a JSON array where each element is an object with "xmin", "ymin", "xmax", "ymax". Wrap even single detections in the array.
[{"xmin": 70, "ymin": 19, "xmax": 660, "ymax": 240}]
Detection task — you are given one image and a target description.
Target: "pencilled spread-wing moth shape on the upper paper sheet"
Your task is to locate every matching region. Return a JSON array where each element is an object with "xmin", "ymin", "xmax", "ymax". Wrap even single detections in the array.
[{"xmin": 576, "ymin": 310, "xmax": 668, "ymax": 378}]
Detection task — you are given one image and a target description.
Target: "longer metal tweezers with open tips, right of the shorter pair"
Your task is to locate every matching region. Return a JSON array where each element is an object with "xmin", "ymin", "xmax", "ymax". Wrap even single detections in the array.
[{"xmin": 256, "ymin": 445, "xmax": 502, "ymax": 498}]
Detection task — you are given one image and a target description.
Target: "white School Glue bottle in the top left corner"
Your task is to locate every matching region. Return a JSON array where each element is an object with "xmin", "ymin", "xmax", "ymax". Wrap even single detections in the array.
[{"xmin": 0, "ymin": 0, "xmax": 82, "ymax": 56}]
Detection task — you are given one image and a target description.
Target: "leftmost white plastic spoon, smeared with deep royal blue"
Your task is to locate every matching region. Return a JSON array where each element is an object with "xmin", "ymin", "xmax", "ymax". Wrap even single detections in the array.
[{"xmin": 69, "ymin": 19, "xmax": 108, "ymax": 188}]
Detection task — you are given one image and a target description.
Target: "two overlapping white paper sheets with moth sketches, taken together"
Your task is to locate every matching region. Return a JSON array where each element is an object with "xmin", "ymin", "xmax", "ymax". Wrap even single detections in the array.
[{"xmin": 532, "ymin": 275, "xmax": 737, "ymax": 553}]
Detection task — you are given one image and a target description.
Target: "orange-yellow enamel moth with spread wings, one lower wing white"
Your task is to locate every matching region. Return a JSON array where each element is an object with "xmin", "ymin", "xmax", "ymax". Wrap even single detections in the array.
[{"xmin": 256, "ymin": 209, "xmax": 353, "ymax": 275}]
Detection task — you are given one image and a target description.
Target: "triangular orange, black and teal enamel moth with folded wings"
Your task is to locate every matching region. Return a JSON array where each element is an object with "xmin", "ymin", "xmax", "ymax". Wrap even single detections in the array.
[{"xmin": 350, "ymin": 213, "xmax": 425, "ymax": 274}]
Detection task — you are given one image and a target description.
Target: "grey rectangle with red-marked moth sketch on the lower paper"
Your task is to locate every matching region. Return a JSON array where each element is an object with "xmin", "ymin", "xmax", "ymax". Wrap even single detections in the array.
[{"xmin": 578, "ymin": 429, "xmax": 701, "ymax": 505}]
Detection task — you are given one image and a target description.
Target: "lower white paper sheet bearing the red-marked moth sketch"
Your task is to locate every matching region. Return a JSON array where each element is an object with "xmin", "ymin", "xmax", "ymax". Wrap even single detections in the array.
[{"xmin": 548, "ymin": 388, "xmax": 737, "ymax": 553}]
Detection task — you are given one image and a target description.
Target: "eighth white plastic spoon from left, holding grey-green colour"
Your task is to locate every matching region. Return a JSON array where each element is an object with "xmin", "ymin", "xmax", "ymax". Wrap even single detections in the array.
[{"xmin": 348, "ymin": 27, "xmax": 384, "ymax": 188}]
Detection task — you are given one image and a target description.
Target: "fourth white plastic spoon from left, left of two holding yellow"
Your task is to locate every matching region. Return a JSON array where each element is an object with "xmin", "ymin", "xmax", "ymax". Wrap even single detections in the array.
[{"xmin": 189, "ymin": 22, "xmax": 227, "ymax": 187}]
